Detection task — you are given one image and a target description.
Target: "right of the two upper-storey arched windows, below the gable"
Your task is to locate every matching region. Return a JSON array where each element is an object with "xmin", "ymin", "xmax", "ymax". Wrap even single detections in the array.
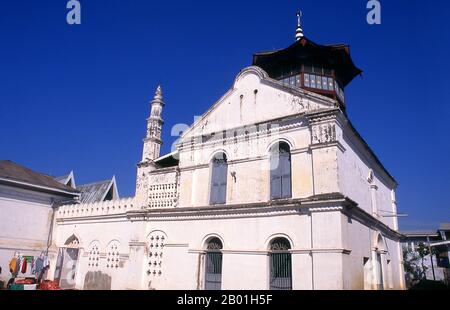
[{"xmin": 270, "ymin": 142, "xmax": 292, "ymax": 199}]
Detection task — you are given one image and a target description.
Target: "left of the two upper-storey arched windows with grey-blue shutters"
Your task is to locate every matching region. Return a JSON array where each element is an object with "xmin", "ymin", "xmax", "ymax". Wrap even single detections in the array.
[{"xmin": 210, "ymin": 153, "xmax": 228, "ymax": 205}]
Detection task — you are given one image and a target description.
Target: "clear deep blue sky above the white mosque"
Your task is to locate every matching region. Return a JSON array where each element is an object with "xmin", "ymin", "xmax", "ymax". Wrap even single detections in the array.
[{"xmin": 0, "ymin": 0, "xmax": 450, "ymax": 229}]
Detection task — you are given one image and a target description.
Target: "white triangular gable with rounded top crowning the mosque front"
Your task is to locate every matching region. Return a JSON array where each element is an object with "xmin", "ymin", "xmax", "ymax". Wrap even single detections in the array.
[{"xmin": 182, "ymin": 66, "xmax": 336, "ymax": 140}]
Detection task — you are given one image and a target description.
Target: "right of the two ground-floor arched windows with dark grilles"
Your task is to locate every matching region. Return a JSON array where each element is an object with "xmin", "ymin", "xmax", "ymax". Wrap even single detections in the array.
[{"xmin": 269, "ymin": 238, "xmax": 292, "ymax": 290}]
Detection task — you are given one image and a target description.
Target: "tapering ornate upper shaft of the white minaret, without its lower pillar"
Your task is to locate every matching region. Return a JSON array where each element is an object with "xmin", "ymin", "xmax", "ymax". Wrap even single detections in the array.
[{"xmin": 142, "ymin": 85, "xmax": 164, "ymax": 163}]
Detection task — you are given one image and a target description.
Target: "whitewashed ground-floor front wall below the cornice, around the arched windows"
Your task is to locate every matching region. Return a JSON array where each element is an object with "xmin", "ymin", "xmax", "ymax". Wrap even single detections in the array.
[{"xmin": 56, "ymin": 201, "xmax": 358, "ymax": 290}]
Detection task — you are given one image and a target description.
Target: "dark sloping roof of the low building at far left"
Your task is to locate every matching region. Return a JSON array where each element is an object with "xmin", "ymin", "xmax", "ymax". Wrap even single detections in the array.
[{"xmin": 0, "ymin": 160, "xmax": 78, "ymax": 193}]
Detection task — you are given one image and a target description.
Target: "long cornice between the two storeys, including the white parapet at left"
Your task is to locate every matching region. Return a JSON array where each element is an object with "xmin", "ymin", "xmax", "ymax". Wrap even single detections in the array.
[{"xmin": 56, "ymin": 193, "xmax": 403, "ymax": 239}]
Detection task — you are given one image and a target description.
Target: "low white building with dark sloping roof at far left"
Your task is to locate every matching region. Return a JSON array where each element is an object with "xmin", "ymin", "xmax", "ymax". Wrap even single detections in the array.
[{"xmin": 0, "ymin": 160, "xmax": 80, "ymax": 283}]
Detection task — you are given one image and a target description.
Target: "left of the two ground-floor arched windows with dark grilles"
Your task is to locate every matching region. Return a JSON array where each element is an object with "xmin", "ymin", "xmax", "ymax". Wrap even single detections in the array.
[{"xmin": 205, "ymin": 238, "xmax": 223, "ymax": 290}]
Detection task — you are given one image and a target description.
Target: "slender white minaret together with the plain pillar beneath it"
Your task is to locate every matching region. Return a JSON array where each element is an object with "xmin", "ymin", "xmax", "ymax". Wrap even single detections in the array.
[{"xmin": 136, "ymin": 86, "xmax": 164, "ymax": 204}]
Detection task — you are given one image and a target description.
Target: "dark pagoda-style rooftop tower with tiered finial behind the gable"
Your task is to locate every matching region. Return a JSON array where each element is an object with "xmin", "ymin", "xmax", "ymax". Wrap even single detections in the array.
[{"xmin": 253, "ymin": 12, "xmax": 362, "ymax": 111}]
